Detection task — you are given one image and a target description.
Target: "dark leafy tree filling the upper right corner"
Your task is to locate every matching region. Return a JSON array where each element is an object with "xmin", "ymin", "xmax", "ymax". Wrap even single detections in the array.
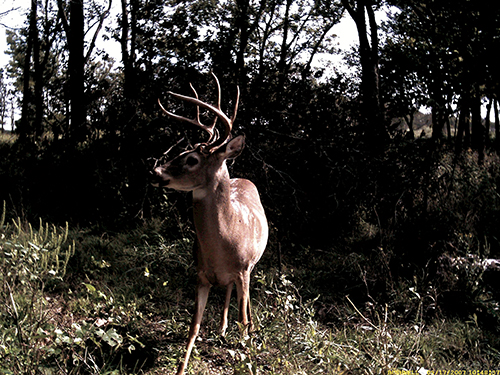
[{"xmin": 392, "ymin": 0, "xmax": 500, "ymax": 155}]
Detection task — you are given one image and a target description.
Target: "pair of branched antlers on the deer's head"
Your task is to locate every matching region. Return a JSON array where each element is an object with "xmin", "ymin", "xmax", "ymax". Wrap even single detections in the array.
[{"xmin": 158, "ymin": 73, "xmax": 240, "ymax": 152}]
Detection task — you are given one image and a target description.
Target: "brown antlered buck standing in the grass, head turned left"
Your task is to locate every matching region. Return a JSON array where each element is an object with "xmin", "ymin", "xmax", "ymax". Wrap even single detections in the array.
[{"xmin": 153, "ymin": 75, "xmax": 268, "ymax": 375}]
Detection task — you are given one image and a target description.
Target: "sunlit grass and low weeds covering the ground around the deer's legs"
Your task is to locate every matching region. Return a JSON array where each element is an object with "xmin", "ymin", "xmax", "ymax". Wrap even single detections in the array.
[{"xmin": 0, "ymin": 203, "xmax": 500, "ymax": 375}]
